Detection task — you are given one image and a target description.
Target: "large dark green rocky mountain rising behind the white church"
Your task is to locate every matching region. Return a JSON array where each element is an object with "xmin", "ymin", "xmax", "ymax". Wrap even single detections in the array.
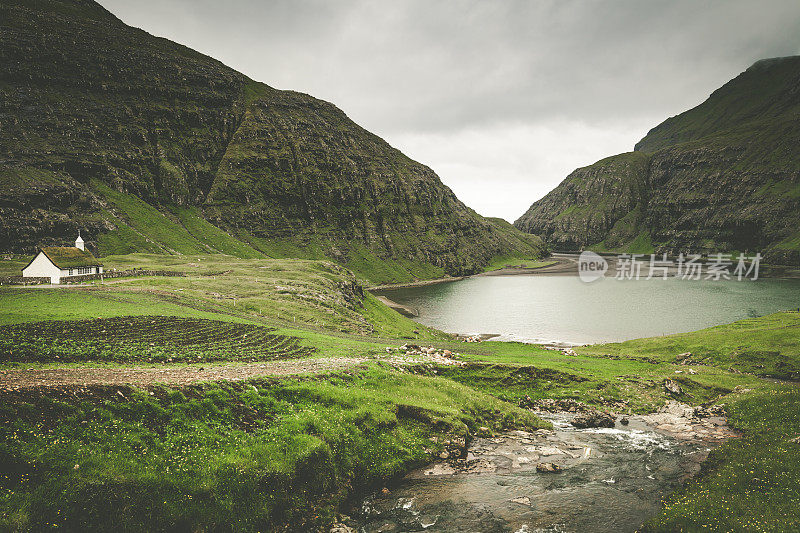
[{"xmin": 0, "ymin": 0, "xmax": 542, "ymax": 281}]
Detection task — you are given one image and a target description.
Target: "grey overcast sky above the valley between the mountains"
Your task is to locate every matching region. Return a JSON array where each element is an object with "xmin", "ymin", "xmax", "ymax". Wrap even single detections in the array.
[{"xmin": 100, "ymin": 0, "xmax": 800, "ymax": 221}]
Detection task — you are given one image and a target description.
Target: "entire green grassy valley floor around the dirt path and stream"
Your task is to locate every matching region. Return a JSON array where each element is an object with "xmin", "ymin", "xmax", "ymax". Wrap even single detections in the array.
[{"xmin": 0, "ymin": 255, "xmax": 800, "ymax": 532}]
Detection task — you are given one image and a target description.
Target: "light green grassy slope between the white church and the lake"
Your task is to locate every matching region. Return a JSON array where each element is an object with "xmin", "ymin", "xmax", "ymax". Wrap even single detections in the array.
[{"xmin": 0, "ymin": 254, "xmax": 444, "ymax": 339}]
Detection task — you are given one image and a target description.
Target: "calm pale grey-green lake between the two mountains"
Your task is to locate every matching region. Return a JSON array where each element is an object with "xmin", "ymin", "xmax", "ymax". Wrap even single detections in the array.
[{"xmin": 381, "ymin": 275, "xmax": 800, "ymax": 344}]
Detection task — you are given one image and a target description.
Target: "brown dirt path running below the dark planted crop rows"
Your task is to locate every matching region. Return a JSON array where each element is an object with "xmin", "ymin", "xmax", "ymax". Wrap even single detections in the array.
[{"xmin": 0, "ymin": 357, "xmax": 366, "ymax": 390}]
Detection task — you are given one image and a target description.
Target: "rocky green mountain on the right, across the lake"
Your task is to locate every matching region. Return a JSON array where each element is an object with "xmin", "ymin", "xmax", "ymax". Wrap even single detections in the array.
[{"xmin": 514, "ymin": 56, "xmax": 800, "ymax": 265}]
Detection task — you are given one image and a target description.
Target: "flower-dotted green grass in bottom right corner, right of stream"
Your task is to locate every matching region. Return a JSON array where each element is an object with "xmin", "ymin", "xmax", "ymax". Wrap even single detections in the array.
[{"xmin": 643, "ymin": 385, "xmax": 800, "ymax": 533}]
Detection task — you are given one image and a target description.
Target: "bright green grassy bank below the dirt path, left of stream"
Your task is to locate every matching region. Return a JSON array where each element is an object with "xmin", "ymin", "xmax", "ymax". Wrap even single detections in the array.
[{"xmin": 0, "ymin": 367, "xmax": 546, "ymax": 531}]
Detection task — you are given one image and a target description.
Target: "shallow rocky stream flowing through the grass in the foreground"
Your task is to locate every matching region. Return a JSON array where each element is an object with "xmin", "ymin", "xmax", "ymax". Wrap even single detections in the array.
[{"xmin": 354, "ymin": 414, "xmax": 710, "ymax": 533}]
